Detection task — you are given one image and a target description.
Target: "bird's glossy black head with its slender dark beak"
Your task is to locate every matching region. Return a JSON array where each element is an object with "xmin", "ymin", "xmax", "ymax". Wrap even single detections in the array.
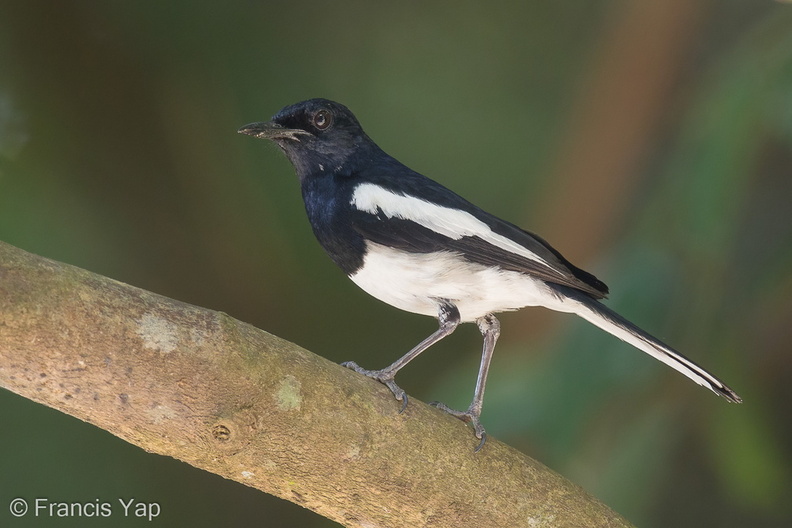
[{"xmin": 239, "ymin": 99, "xmax": 379, "ymax": 180}]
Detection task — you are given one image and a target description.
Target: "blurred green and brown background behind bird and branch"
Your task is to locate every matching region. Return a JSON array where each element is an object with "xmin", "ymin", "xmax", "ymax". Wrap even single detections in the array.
[{"xmin": 0, "ymin": 0, "xmax": 792, "ymax": 527}]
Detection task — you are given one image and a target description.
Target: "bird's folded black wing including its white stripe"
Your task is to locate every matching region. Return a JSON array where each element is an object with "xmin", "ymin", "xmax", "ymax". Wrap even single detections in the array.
[{"xmin": 351, "ymin": 183, "xmax": 608, "ymax": 299}]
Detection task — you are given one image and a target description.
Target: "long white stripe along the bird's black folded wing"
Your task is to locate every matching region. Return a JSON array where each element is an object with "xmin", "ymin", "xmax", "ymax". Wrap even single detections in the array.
[{"xmin": 350, "ymin": 183, "xmax": 552, "ymax": 269}]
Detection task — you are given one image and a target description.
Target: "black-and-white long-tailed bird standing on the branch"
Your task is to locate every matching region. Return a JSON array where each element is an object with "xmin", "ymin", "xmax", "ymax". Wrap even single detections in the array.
[{"xmin": 238, "ymin": 98, "xmax": 742, "ymax": 451}]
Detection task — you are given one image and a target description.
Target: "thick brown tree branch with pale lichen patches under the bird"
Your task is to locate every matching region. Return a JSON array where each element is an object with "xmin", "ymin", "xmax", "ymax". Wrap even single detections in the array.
[{"xmin": 0, "ymin": 242, "xmax": 629, "ymax": 527}]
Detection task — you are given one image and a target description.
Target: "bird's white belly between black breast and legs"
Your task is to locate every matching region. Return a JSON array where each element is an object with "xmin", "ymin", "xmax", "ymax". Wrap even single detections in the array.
[{"xmin": 350, "ymin": 242, "xmax": 567, "ymax": 322}]
